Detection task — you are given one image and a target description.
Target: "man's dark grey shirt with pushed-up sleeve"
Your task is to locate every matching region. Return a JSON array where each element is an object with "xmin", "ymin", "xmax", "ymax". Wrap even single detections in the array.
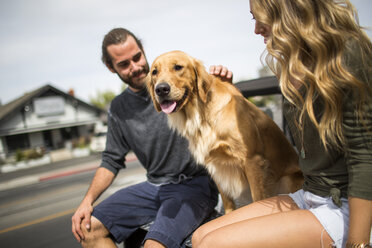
[{"xmin": 101, "ymin": 88, "xmax": 206, "ymax": 184}]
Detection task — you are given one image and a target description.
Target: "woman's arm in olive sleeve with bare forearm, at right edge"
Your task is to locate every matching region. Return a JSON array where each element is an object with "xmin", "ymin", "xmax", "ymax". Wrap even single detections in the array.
[{"xmin": 343, "ymin": 82, "xmax": 372, "ymax": 247}]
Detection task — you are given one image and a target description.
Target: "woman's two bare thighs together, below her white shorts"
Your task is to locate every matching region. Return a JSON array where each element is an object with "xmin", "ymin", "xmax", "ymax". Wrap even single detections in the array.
[{"xmin": 193, "ymin": 195, "xmax": 332, "ymax": 247}]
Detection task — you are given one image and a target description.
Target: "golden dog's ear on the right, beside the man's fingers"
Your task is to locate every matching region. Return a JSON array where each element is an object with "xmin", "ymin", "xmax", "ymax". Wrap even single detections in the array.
[{"xmin": 193, "ymin": 58, "xmax": 212, "ymax": 103}]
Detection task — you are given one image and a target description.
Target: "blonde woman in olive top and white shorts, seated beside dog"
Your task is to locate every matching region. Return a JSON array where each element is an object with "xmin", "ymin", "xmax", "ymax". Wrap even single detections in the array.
[{"xmin": 193, "ymin": 0, "xmax": 372, "ymax": 248}]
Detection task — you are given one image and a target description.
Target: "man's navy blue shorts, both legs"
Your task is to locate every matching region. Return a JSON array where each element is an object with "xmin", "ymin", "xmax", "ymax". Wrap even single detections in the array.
[{"xmin": 92, "ymin": 176, "xmax": 218, "ymax": 248}]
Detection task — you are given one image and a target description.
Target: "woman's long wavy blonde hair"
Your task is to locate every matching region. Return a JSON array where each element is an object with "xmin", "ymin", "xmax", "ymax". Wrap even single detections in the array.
[{"xmin": 251, "ymin": 0, "xmax": 372, "ymax": 148}]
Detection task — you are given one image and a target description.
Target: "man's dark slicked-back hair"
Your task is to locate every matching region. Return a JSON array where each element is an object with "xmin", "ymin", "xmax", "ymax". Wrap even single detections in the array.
[{"xmin": 101, "ymin": 28, "xmax": 143, "ymax": 68}]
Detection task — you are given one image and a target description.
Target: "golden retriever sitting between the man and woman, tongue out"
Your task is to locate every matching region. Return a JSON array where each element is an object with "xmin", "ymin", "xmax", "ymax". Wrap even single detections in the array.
[{"xmin": 147, "ymin": 51, "xmax": 303, "ymax": 213}]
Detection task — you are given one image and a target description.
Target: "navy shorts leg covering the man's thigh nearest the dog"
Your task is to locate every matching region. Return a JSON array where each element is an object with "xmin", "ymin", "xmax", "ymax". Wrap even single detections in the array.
[{"xmin": 145, "ymin": 176, "xmax": 218, "ymax": 248}]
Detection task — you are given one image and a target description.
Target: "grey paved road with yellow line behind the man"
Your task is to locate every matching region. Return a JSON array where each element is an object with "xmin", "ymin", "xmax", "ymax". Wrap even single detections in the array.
[{"xmin": 0, "ymin": 158, "xmax": 145, "ymax": 248}]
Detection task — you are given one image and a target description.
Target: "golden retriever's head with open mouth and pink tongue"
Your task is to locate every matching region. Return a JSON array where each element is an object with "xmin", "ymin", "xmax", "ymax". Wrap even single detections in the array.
[{"xmin": 147, "ymin": 51, "xmax": 211, "ymax": 114}]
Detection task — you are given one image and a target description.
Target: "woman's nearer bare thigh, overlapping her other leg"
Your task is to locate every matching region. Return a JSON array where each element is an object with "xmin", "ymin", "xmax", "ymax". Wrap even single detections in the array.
[{"xmin": 196, "ymin": 210, "xmax": 333, "ymax": 248}]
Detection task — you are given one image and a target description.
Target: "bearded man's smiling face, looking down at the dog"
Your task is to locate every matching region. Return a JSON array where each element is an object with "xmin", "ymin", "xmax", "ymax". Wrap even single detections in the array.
[{"xmin": 107, "ymin": 36, "xmax": 149, "ymax": 91}]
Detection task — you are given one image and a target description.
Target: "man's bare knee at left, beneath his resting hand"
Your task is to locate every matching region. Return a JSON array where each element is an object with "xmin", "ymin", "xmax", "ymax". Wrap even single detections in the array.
[{"xmin": 81, "ymin": 216, "xmax": 110, "ymax": 247}]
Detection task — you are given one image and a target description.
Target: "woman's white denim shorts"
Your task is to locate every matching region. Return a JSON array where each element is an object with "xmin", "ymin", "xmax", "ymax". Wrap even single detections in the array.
[{"xmin": 289, "ymin": 189, "xmax": 349, "ymax": 248}]
